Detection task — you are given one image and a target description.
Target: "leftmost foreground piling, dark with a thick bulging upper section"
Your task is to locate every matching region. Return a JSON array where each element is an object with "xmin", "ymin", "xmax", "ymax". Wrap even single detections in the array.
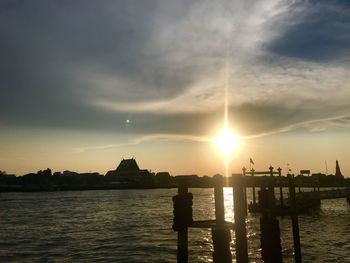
[{"xmin": 173, "ymin": 183, "xmax": 193, "ymax": 263}]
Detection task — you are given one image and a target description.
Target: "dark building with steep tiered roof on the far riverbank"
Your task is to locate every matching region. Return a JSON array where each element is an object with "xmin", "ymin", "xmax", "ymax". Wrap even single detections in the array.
[{"xmin": 106, "ymin": 158, "xmax": 153, "ymax": 184}]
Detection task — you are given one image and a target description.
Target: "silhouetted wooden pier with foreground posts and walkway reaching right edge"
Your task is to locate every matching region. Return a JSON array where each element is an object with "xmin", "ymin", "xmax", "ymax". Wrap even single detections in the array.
[{"xmin": 173, "ymin": 167, "xmax": 350, "ymax": 263}]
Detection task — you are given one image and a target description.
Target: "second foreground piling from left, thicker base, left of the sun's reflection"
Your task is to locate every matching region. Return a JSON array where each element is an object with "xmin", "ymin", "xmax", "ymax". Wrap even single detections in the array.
[{"xmin": 212, "ymin": 177, "xmax": 232, "ymax": 263}]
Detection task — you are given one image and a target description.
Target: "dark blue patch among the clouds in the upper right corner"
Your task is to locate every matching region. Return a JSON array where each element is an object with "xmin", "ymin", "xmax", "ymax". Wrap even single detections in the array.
[{"xmin": 267, "ymin": 0, "xmax": 350, "ymax": 62}]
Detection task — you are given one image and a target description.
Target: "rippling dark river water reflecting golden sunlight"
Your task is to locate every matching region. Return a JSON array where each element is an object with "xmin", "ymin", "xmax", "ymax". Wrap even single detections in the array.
[{"xmin": 0, "ymin": 188, "xmax": 350, "ymax": 263}]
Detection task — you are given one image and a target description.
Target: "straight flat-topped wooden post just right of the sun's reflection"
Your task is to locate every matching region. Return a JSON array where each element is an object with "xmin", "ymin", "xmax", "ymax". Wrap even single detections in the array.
[{"xmin": 232, "ymin": 175, "xmax": 248, "ymax": 263}]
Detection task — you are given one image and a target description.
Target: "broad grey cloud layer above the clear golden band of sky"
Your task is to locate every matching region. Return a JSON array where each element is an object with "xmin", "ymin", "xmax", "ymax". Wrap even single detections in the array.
[{"xmin": 0, "ymin": 0, "xmax": 350, "ymax": 140}]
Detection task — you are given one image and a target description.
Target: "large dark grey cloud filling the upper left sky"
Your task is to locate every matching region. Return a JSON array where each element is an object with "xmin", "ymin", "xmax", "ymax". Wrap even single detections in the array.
[{"xmin": 0, "ymin": 0, "xmax": 200, "ymax": 128}]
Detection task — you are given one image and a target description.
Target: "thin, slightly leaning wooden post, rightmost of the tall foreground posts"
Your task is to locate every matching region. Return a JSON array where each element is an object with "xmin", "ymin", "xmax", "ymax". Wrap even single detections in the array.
[{"xmin": 288, "ymin": 175, "xmax": 301, "ymax": 263}]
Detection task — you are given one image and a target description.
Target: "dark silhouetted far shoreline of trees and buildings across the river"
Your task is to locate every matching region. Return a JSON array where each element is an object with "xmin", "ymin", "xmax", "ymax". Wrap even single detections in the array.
[{"xmin": 0, "ymin": 158, "xmax": 350, "ymax": 193}]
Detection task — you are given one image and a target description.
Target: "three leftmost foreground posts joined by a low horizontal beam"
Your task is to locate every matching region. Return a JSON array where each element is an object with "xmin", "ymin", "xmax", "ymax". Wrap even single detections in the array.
[{"xmin": 173, "ymin": 177, "xmax": 243, "ymax": 263}]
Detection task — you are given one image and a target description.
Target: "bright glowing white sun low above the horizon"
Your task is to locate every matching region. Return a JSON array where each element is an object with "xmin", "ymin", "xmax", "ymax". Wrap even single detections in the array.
[{"xmin": 213, "ymin": 126, "xmax": 240, "ymax": 158}]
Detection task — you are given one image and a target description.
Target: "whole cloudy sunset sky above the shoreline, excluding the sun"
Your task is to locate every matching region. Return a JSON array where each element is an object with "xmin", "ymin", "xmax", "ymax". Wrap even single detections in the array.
[{"xmin": 0, "ymin": 0, "xmax": 350, "ymax": 177}]
